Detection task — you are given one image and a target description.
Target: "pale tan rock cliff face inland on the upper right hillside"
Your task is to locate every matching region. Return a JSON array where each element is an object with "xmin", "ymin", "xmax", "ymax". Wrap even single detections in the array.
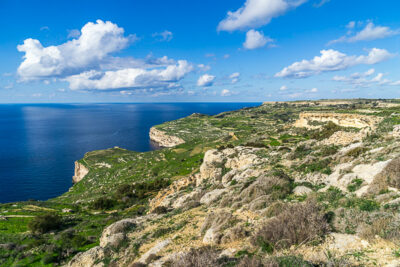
[{"xmin": 294, "ymin": 112, "xmax": 381, "ymax": 128}]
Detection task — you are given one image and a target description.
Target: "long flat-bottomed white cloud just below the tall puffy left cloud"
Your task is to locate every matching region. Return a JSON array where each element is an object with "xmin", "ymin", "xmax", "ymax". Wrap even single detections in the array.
[{"xmin": 65, "ymin": 60, "xmax": 193, "ymax": 90}]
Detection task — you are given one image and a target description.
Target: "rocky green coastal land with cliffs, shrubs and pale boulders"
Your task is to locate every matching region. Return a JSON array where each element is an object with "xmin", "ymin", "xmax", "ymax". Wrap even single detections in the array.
[{"xmin": 0, "ymin": 100, "xmax": 400, "ymax": 267}]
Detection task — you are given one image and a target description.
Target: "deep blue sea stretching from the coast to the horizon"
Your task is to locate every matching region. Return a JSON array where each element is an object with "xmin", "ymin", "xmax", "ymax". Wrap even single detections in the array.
[{"xmin": 0, "ymin": 103, "xmax": 260, "ymax": 203}]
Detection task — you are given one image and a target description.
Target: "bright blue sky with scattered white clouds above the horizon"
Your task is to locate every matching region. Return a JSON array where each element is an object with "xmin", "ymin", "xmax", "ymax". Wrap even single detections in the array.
[{"xmin": 0, "ymin": 0, "xmax": 400, "ymax": 103}]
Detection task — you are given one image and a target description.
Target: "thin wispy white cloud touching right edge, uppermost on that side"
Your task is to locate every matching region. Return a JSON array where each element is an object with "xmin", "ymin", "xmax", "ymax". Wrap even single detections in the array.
[{"xmin": 329, "ymin": 21, "xmax": 400, "ymax": 44}]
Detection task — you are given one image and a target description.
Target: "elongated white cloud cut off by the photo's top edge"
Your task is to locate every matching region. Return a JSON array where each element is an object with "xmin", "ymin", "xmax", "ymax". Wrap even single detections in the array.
[{"xmin": 218, "ymin": 0, "xmax": 306, "ymax": 31}]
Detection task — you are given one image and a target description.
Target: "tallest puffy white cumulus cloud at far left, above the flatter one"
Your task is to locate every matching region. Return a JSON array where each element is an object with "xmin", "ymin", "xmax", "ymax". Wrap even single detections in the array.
[{"xmin": 17, "ymin": 20, "xmax": 134, "ymax": 81}]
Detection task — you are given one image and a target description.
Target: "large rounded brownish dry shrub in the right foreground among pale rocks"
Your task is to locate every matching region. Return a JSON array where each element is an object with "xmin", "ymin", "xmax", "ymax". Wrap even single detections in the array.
[{"xmin": 251, "ymin": 201, "xmax": 329, "ymax": 250}]
